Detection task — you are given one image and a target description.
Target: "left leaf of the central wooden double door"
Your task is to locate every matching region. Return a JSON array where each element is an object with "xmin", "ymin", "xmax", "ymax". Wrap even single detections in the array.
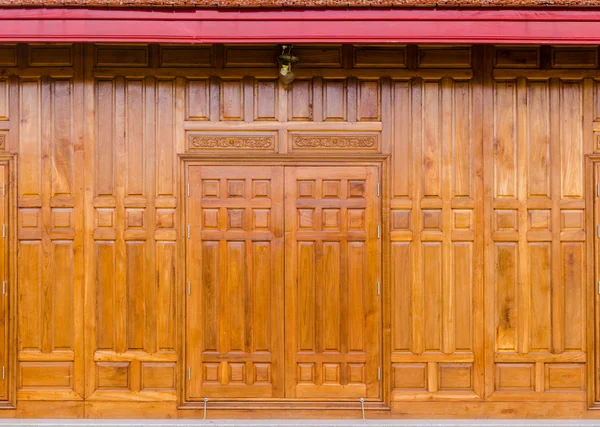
[{"xmin": 186, "ymin": 166, "xmax": 284, "ymax": 400}]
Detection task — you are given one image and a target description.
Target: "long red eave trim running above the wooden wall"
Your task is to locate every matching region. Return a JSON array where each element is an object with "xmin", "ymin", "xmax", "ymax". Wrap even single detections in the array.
[{"xmin": 0, "ymin": 8, "xmax": 600, "ymax": 44}]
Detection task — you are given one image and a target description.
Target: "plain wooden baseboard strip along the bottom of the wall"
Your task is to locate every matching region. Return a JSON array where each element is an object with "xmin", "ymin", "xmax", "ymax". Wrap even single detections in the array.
[{"xmin": 0, "ymin": 401, "xmax": 600, "ymax": 420}]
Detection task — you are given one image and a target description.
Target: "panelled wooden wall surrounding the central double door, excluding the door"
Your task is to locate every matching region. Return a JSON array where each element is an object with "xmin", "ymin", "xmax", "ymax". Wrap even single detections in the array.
[{"xmin": 0, "ymin": 44, "xmax": 600, "ymax": 417}]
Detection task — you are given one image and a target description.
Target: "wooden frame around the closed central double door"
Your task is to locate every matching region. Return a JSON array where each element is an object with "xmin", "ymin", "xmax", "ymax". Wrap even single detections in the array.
[{"xmin": 176, "ymin": 152, "xmax": 391, "ymax": 411}]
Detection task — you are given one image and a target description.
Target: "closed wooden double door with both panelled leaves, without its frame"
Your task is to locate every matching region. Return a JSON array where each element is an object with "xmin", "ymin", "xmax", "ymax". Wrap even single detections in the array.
[{"xmin": 186, "ymin": 164, "xmax": 381, "ymax": 401}]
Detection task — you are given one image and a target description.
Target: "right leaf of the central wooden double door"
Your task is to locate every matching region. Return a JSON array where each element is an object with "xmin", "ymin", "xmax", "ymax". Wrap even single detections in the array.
[{"xmin": 285, "ymin": 167, "xmax": 380, "ymax": 400}]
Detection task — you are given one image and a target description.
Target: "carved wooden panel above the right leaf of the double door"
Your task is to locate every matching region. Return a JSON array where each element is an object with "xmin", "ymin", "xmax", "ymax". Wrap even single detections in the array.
[{"xmin": 292, "ymin": 134, "xmax": 379, "ymax": 151}]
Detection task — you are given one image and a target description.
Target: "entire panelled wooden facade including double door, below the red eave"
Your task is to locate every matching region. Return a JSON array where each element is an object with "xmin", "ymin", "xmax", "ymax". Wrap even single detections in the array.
[{"xmin": 0, "ymin": 44, "xmax": 600, "ymax": 418}]
